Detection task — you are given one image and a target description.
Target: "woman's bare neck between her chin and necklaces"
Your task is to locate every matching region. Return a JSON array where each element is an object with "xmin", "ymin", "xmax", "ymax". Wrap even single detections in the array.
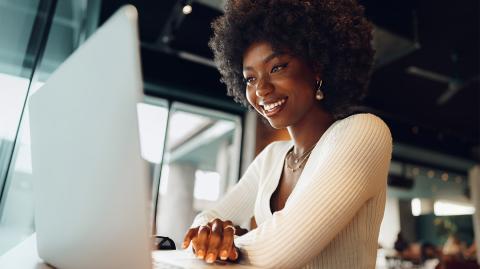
[{"xmin": 287, "ymin": 106, "xmax": 335, "ymax": 155}]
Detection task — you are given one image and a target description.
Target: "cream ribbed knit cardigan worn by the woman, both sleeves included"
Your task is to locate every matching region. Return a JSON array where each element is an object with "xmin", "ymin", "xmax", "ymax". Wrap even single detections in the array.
[{"xmin": 192, "ymin": 113, "xmax": 392, "ymax": 269}]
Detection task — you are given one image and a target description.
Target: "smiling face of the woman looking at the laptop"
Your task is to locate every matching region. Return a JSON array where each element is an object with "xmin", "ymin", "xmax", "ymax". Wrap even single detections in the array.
[{"xmin": 243, "ymin": 42, "xmax": 320, "ymax": 129}]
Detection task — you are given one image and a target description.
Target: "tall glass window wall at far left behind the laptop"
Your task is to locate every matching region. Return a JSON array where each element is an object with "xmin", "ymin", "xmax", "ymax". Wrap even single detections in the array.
[{"xmin": 0, "ymin": 0, "xmax": 99, "ymax": 255}]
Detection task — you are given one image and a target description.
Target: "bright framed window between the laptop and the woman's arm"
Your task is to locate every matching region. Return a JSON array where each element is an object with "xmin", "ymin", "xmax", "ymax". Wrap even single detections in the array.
[{"xmin": 157, "ymin": 103, "xmax": 241, "ymax": 244}]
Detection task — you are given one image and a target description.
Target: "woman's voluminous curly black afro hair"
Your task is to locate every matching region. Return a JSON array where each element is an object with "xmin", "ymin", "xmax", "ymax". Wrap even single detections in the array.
[{"xmin": 209, "ymin": 0, "xmax": 374, "ymax": 118}]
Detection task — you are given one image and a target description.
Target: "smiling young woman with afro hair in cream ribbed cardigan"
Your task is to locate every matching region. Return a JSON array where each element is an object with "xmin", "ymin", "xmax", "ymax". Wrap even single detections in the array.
[{"xmin": 183, "ymin": 0, "xmax": 392, "ymax": 269}]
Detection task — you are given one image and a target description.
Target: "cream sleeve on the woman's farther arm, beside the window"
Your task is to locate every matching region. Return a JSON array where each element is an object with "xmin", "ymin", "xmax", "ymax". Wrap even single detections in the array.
[{"xmin": 191, "ymin": 141, "xmax": 273, "ymax": 227}]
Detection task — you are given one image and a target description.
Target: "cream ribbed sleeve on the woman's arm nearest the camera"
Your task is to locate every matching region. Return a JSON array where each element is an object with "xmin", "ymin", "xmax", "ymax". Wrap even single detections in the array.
[{"xmin": 235, "ymin": 114, "xmax": 392, "ymax": 268}]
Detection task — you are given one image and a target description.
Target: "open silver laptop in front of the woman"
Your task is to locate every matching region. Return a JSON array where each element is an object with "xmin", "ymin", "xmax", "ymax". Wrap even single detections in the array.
[{"xmin": 29, "ymin": 6, "xmax": 255, "ymax": 269}]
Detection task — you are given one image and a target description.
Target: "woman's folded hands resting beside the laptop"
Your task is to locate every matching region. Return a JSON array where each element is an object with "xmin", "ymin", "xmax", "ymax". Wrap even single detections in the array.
[{"xmin": 182, "ymin": 219, "xmax": 248, "ymax": 263}]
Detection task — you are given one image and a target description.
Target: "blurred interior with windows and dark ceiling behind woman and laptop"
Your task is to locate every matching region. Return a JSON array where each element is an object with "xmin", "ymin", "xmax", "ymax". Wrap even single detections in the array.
[{"xmin": 0, "ymin": 0, "xmax": 480, "ymax": 268}]
